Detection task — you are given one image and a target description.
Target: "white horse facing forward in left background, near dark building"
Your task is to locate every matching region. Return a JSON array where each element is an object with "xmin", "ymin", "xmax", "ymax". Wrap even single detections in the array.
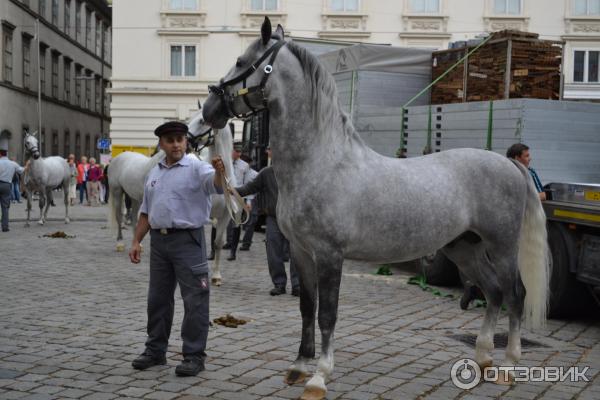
[{"xmin": 23, "ymin": 132, "xmax": 71, "ymax": 226}]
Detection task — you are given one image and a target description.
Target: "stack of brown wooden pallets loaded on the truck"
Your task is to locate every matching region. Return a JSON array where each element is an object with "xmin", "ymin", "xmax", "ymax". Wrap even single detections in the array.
[{"xmin": 431, "ymin": 30, "xmax": 563, "ymax": 104}]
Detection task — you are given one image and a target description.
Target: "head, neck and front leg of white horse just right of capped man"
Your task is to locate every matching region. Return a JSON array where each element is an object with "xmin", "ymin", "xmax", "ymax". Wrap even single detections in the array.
[{"xmin": 189, "ymin": 112, "xmax": 241, "ymax": 286}]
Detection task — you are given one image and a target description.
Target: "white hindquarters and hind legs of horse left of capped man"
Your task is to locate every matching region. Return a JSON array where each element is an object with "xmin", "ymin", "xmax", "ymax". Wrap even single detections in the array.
[{"xmin": 107, "ymin": 150, "xmax": 165, "ymax": 251}]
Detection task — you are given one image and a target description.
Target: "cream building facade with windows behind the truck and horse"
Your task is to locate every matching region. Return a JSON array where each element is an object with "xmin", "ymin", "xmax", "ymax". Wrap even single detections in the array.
[{"xmin": 111, "ymin": 0, "xmax": 600, "ymax": 146}]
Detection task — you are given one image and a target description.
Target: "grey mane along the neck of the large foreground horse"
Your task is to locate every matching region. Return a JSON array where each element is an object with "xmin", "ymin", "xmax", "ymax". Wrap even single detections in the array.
[{"xmin": 287, "ymin": 41, "xmax": 363, "ymax": 143}]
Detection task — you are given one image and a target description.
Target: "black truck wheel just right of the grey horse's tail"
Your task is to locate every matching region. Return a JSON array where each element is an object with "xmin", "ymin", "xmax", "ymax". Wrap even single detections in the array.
[{"xmin": 548, "ymin": 223, "xmax": 587, "ymax": 318}]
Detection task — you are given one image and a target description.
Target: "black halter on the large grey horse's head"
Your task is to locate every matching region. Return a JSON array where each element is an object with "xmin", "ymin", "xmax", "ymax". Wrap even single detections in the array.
[{"xmin": 208, "ymin": 39, "xmax": 286, "ymax": 118}]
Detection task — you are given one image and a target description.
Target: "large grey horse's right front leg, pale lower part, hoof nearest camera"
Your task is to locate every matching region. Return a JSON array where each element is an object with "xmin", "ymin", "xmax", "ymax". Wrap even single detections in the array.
[{"xmin": 301, "ymin": 249, "xmax": 344, "ymax": 400}]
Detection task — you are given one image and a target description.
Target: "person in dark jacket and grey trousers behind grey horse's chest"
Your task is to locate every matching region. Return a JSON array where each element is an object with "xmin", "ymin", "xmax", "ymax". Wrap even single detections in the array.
[{"xmin": 236, "ymin": 166, "xmax": 300, "ymax": 296}]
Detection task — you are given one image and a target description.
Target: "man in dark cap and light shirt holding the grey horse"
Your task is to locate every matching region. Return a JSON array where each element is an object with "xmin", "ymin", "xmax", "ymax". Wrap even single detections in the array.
[{"xmin": 129, "ymin": 121, "xmax": 225, "ymax": 376}]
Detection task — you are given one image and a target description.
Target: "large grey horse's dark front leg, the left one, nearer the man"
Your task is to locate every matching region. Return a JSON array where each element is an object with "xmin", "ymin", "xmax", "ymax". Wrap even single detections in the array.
[{"xmin": 285, "ymin": 243, "xmax": 317, "ymax": 385}]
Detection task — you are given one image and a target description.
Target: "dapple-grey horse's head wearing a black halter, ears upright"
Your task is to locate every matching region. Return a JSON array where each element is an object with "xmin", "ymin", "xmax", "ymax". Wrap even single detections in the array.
[{"xmin": 203, "ymin": 17, "xmax": 287, "ymax": 128}]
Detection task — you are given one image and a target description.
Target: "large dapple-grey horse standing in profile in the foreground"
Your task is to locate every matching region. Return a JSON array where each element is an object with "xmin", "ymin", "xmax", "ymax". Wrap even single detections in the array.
[{"xmin": 203, "ymin": 18, "xmax": 548, "ymax": 399}]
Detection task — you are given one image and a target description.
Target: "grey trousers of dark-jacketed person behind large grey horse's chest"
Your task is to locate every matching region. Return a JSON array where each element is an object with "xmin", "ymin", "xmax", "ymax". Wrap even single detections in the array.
[{"xmin": 266, "ymin": 216, "xmax": 300, "ymax": 288}]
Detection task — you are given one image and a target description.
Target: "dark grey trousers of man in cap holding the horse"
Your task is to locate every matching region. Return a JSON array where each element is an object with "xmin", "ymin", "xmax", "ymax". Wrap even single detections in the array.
[{"xmin": 146, "ymin": 228, "xmax": 210, "ymax": 357}]
